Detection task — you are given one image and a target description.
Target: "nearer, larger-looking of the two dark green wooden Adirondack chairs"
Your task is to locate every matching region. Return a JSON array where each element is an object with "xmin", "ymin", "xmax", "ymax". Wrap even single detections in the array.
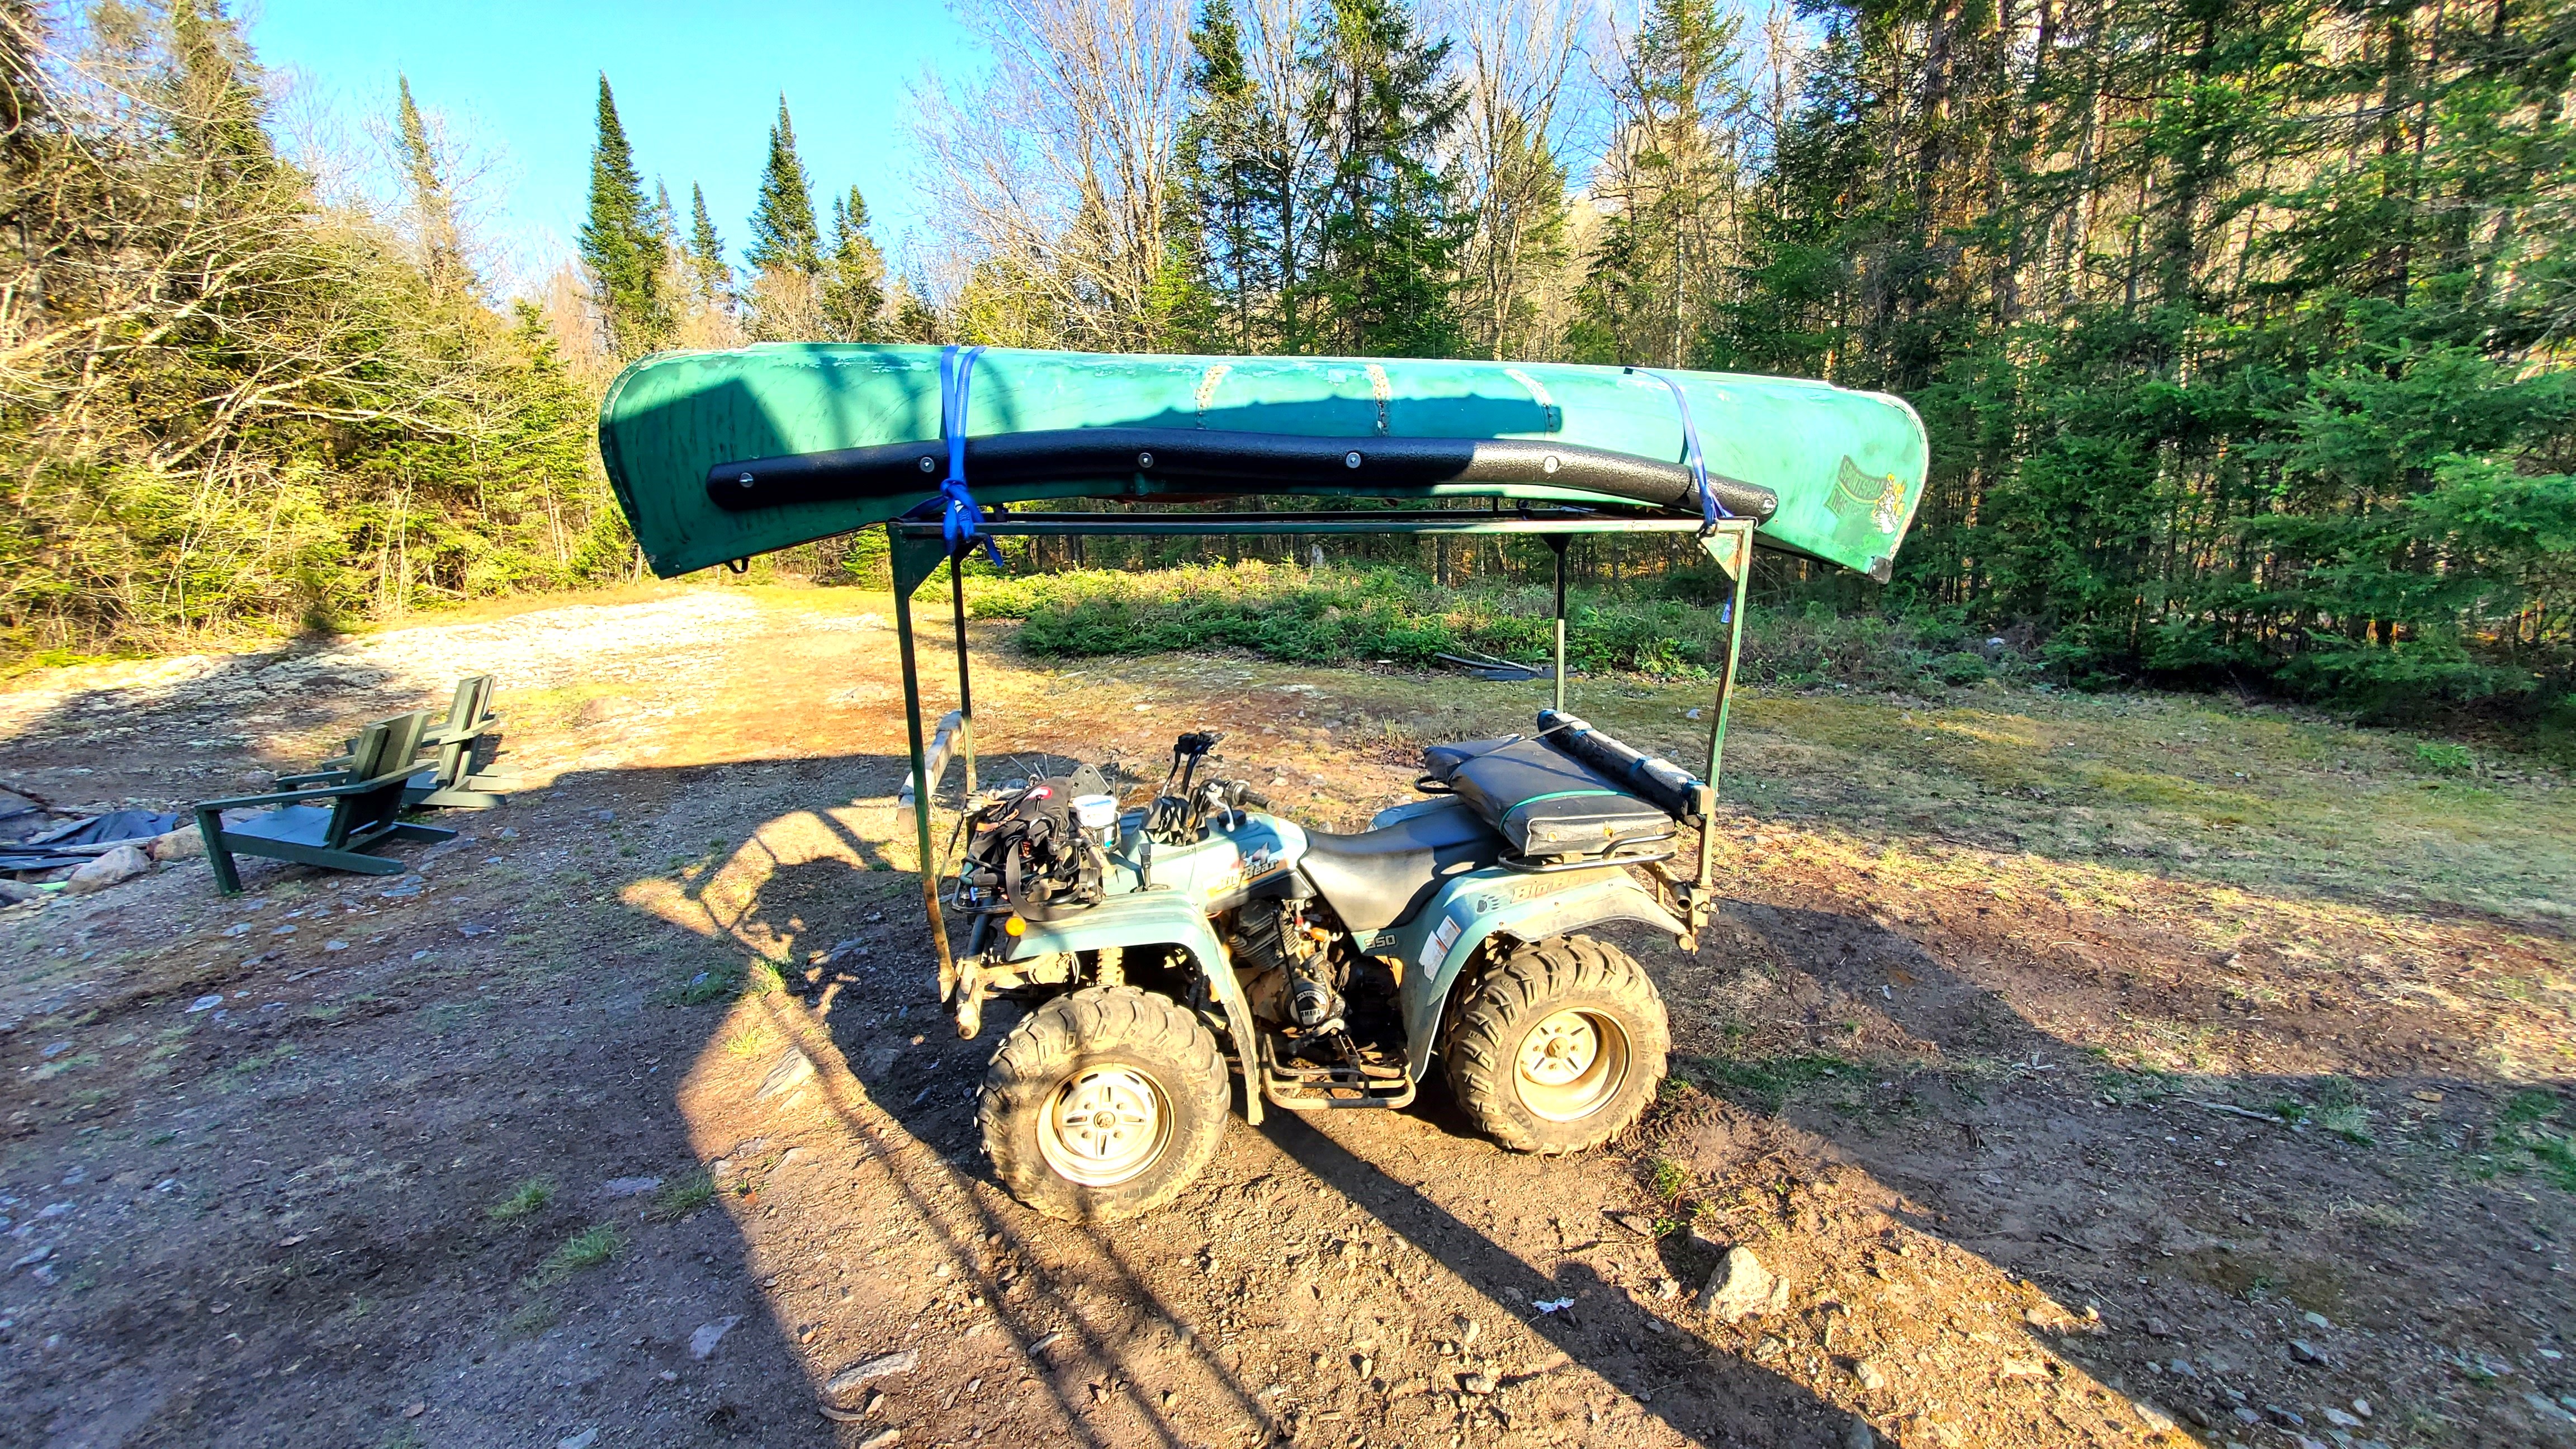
[{"xmin": 196, "ymin": 709, "xmax": 456, "ymax": 894}]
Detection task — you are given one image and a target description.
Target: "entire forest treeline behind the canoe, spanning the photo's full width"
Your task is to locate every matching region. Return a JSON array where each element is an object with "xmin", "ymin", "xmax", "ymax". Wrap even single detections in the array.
[{"xmin": 0, "ymin": 0, "xmax": 2576, "ymax": 727}]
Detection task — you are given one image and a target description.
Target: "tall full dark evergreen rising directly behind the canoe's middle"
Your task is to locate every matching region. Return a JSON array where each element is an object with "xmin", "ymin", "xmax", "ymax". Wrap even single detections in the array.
[{"xmin": 1306, "ymin": 0, "xmax": 1466, "ymax": 356}]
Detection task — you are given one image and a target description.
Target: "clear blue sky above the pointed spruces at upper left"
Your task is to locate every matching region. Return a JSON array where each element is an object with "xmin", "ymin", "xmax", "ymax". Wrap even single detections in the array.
[{"xmin": 250, "ymin": 0, "xmax": 979, "ymax": 287}]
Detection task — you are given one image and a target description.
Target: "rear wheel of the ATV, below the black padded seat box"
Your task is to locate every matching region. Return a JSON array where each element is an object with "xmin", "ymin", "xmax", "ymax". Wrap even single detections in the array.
[{"xmin": 1442, "ymin": 936, "xmax": 1672, "ymax": 1153}]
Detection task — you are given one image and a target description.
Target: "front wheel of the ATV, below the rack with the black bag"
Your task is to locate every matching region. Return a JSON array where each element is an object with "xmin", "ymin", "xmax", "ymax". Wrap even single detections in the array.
[{"xmin": 976, "ymin": 985, "xmax": 1232, "ymax": 1222}]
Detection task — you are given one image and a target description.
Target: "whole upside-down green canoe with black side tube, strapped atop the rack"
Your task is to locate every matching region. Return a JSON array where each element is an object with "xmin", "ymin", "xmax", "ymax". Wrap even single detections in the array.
[{"xmin": 600, "ymin": 343, "xmax": 1929, "ymax": 577}]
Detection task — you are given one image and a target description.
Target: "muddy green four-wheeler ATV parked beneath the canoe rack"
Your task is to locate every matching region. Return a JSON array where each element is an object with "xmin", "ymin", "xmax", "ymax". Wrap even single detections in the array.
[{"xmin": 943, "ymin": 709, "xmax": 1708, "ymax": 1222}]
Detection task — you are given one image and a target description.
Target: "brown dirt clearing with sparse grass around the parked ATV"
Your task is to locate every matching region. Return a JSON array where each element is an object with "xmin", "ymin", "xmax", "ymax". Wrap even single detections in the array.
[{"xmin": 0, "ymin": 577, "xmax": 2576, "ymax": 1449}]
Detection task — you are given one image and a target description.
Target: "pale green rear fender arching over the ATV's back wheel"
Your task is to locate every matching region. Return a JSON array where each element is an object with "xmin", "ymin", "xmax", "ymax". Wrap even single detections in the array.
[{"xmin": 1394, "ymin": 866, "xmax": 1690, "ymax": 1083}]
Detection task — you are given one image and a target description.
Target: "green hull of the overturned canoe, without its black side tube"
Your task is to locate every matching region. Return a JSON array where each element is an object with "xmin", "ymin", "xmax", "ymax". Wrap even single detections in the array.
[{"xmin": 600, "ymin": 343, "xmax": 1927, "ymax": 577}]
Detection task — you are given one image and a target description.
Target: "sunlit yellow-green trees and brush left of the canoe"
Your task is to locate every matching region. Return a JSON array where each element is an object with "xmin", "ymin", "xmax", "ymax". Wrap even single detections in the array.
[{"xmin": 0, "ymin": 0, "xmax": 631, "ymax": 652}]
